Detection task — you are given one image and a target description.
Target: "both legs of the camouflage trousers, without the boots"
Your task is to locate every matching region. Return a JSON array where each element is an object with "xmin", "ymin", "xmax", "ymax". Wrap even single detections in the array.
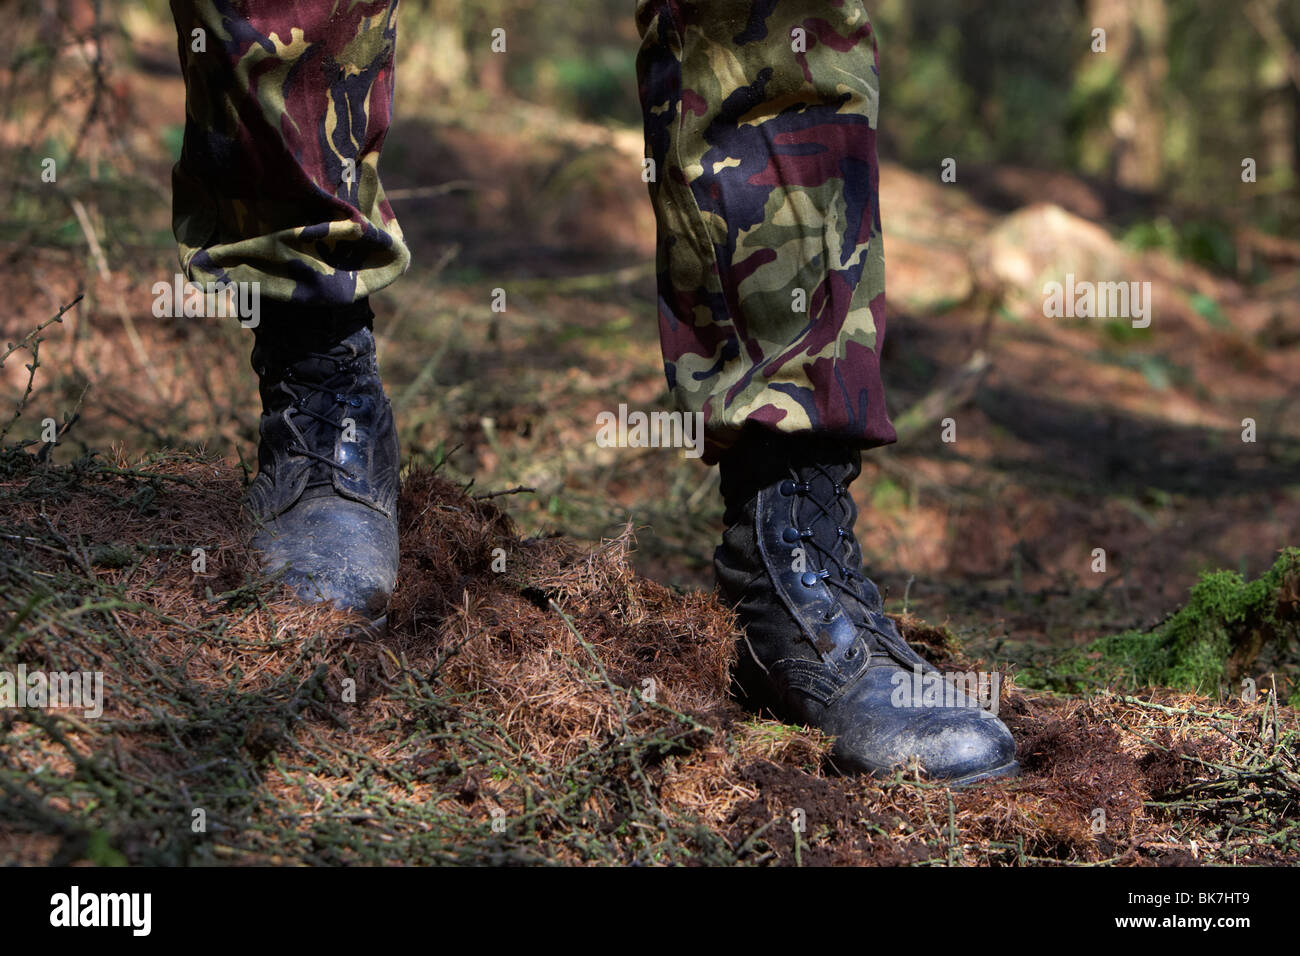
[{"xmin": 172, "ymin": 0, "xmax": 894, "ymax": 460}]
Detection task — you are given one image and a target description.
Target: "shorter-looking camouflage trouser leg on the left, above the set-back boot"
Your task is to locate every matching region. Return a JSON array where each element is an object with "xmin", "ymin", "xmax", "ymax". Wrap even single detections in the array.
[{"xmin": 172, "ymin": 0, "xmax": 411, "ymax": 306}]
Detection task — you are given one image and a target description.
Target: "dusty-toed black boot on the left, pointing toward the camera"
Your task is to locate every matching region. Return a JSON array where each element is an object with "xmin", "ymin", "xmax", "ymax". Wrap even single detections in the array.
[{"xmin": 246, "ymin": 300, "xmax": 399, "ymax": 633}]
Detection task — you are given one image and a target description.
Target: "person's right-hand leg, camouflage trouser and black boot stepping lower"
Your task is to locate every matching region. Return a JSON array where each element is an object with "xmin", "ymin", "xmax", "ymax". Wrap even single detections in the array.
[{"xmin": 638, "ymin": 0, "xmax": 1018, "ymax": 782}]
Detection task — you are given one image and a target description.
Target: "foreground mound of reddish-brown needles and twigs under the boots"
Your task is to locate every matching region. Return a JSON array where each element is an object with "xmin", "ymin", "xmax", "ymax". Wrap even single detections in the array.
[{"xmin": 0, "ymin": 453, "xmax": 1300, "ymax": 865}]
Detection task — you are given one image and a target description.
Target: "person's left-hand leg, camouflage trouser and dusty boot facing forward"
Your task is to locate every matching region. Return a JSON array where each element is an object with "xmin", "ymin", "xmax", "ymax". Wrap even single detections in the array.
[{"xmin": 172, "ymin": 0, "xmax": 410, "ymax": 626}]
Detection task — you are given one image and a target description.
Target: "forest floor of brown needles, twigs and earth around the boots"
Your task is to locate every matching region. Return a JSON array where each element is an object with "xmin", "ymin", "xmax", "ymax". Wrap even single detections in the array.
[{"xmin": 0, "ymin": 22, "xmax": 1300, "ymax": 865}]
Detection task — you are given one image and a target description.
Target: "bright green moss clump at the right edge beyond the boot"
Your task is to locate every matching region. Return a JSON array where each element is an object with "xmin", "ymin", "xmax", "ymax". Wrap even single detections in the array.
[{"xmin": 1039, "ymin": 548, "xmax": 1300, "ymax": 693}]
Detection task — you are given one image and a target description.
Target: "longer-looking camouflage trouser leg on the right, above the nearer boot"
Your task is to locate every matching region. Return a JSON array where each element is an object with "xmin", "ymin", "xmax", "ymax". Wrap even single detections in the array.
[{"xmin": 637, "ymin": 0, "xmax": 894, "ymax": 460}]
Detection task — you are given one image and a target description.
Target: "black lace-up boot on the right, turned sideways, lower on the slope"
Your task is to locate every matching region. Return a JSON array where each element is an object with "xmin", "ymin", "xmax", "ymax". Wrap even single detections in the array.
[{"xmin": 714, "ymin": 431, "xmax": 1019, "ymax": 783}]
